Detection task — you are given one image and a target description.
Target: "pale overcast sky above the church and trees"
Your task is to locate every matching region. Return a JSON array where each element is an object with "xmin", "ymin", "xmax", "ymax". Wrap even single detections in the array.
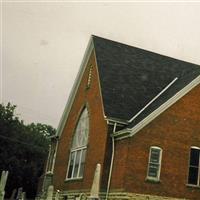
[{"xmin": 0, "ymin": 0, "xmax": 200, "ymax": 128}]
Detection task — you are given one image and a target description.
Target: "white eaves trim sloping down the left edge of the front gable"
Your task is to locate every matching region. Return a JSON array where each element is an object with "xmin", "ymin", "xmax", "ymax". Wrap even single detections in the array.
[{"xmin": 56, "ymin": 36, "xmax": 94, "ymax": 136}]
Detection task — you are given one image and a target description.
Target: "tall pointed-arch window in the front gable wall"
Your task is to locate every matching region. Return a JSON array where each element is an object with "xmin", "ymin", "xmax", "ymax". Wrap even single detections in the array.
[{"xmin": 67, "ymin": 108, "xmax": 89, "ymax": 179}]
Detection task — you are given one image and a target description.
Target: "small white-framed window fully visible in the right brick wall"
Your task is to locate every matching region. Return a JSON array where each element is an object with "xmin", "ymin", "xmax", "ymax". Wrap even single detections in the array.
[{"xmin": 147, "ymin": 146, "xmax": 162, "ymax": 181}]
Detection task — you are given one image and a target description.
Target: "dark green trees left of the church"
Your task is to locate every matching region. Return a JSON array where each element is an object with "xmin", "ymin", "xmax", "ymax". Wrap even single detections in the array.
[{"xmin": 0, "ymin": 103, "xmax": 56, "ymax": 198}]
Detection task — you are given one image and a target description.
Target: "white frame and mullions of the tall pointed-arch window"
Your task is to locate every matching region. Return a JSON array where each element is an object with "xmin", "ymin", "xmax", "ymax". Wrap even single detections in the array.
[{"xmin": 66, "ymin": 107, "xmax": 89, "ymax": 180}]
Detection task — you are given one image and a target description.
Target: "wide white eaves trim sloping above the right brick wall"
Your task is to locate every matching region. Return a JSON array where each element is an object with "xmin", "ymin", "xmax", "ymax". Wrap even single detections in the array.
[{"xmin": 113, "ymin": 76, "xmax": 200, "ymax": 140}]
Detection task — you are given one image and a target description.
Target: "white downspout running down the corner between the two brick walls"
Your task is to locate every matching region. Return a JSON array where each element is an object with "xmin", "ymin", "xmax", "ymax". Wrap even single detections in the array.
[{"xmin": 105, "ymin": 123, "xmax": 117, "ymax": 200}]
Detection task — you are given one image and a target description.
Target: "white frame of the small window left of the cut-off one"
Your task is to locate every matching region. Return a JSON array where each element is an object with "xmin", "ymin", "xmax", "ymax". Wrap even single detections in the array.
[{"xmin": 146, "ymin": 146, "xmax": 162, "ymax": 182}]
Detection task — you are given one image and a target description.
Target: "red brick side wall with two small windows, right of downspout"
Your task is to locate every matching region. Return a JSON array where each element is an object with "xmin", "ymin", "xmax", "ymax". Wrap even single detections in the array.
[{"xmin": 111, "ymin": 85, "xmax": 200, "ymax": 199}]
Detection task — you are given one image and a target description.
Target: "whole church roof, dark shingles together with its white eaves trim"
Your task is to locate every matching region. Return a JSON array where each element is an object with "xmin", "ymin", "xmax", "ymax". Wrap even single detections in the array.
[{"xmin": 56, "ymin": 36, "xmax": 200, "ymax": 139}]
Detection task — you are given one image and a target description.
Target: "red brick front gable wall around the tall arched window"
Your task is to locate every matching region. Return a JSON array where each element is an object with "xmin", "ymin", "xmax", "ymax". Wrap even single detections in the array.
[{"xmin": 53, "ymin": 52, "xmax": 107, "ymax": 190}]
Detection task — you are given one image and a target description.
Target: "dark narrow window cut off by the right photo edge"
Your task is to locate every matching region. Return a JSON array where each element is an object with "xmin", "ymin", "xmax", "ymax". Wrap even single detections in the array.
[{"xmin": 188, "ymin": 147, "xmax": 200, "ymax": 186}]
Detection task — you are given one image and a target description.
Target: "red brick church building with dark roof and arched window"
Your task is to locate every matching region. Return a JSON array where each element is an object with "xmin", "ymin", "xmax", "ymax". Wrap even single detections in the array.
[{"xmin": 40, "ymin": 36, "xmax": 200, "ymax": 200}]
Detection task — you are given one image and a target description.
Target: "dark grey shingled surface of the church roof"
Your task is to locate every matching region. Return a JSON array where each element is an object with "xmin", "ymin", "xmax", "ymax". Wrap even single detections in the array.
[{"xmin": 93, "ymin": 36, "xmax": 200, "ymax": 126}]
